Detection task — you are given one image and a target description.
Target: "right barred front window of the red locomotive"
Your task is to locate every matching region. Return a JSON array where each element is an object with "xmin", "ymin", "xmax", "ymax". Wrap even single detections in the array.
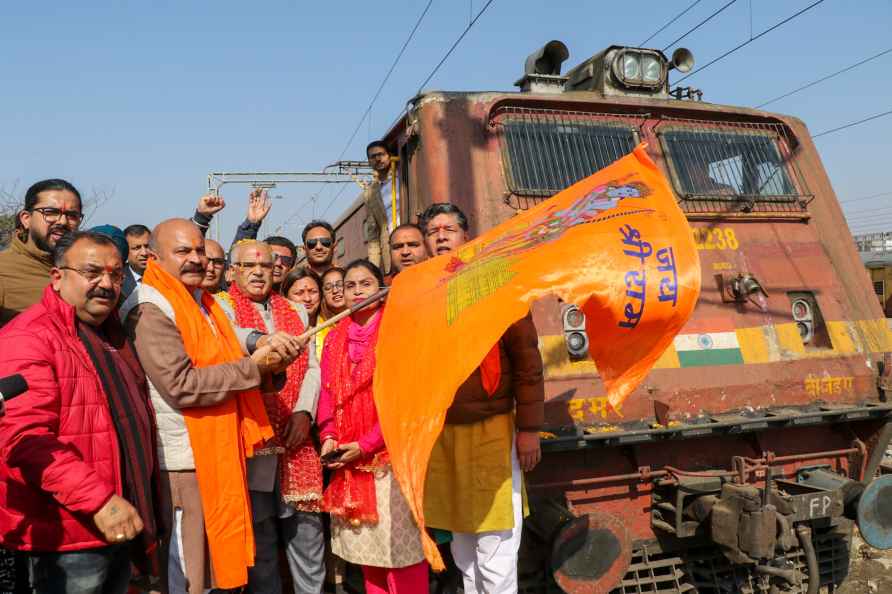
[{"xmin": 661, "ymin": 130, "xmax": 801, "ymax": 202}]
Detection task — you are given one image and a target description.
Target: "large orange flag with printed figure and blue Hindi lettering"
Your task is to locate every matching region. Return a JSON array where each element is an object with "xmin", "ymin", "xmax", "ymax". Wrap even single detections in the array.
[{"xmin": 374, "ymin": 144, "xmax": 700, "ymax": 569}]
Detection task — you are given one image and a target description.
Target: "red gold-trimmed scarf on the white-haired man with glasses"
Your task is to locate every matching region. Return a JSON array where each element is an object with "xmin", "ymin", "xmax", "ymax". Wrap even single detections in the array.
[{"xmin": 221, "ymin": 283, "xmax": 322, "ymax": 512}]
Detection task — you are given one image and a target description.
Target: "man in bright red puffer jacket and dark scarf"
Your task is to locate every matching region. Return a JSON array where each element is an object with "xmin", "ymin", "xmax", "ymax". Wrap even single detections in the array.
[{"xmin": 0, "ymin": 232, "xmax": 156, "ymax": 594}]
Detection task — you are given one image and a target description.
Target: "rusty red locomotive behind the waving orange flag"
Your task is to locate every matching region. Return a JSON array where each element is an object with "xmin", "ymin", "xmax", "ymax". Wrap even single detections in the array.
[{"xmin": 336, "ymin": 42, "xmax": 892, "ymax": 594}]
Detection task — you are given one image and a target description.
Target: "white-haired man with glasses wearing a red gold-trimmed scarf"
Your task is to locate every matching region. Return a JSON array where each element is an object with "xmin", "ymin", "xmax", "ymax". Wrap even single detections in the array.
[{"xmin": 216, "ymin": 240, "xmax": 325, "ymax": 594}]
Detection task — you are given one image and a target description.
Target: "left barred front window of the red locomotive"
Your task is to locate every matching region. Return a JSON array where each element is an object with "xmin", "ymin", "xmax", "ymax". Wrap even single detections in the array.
[{"xmin": 500, "ymin": 114, "xmax": 636, "ymax": 197}]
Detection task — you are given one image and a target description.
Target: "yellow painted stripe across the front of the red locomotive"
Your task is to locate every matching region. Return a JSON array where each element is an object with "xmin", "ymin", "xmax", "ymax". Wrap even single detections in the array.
[{"xmin": 539, "ymin": 318, "xmax": 892, "ymax": 379}]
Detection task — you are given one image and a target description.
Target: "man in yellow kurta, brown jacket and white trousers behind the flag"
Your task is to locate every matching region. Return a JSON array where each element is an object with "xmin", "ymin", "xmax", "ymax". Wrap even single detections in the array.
[{"xmin": 421, "ymin": 203, "xmax": 545, "ymax": 594}]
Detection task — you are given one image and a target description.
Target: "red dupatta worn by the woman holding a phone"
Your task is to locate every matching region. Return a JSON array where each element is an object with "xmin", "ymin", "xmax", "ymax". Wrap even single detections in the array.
[{"xmin": 322, "ymin": 311, "xmax": 390, "ymax": 525}]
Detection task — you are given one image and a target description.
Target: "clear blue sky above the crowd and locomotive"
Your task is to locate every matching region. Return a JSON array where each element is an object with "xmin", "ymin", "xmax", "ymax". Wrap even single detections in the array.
[{"xmin": 0, "ymin": 0, "xmax": 892, "ymax": 241}]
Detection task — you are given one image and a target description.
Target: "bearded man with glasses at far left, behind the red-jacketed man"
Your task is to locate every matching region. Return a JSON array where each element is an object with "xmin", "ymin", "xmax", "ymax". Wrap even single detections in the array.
[{"xmin": 0, "ymin": 179, "xmax": 84, "ymax": 327}]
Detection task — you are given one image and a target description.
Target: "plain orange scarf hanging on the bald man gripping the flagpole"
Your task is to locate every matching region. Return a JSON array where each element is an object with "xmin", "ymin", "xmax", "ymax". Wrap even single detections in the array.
[{"xmin": 142, "ymin": 260, "xmax": 274, "ymax": 588}]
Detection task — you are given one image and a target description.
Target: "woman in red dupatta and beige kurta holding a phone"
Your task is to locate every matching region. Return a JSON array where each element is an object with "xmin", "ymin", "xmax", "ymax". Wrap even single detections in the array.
[{"xmin": 317, "ymin": 260, "xmax": 428, "ymax": 594}]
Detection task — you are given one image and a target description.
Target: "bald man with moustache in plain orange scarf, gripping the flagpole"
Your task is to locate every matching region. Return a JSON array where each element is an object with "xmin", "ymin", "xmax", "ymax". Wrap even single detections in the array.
[{"xmin": 121, "ymin": 219, "xmax": 299, "ymax": 594}]
